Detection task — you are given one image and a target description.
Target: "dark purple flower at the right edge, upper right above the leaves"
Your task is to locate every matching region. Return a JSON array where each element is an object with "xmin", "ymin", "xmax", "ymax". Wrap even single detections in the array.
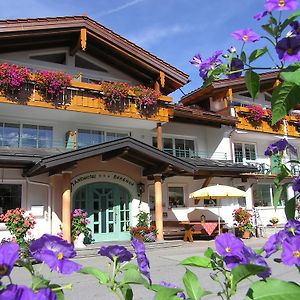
[{"xmin": 275, "ymin": 35, "xmax": 300, "ymax": 62}]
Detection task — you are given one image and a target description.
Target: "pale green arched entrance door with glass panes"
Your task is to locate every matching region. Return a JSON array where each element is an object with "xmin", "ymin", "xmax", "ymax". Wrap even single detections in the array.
[{"xmin": 74, "ymin": 183, "xmax": 131, "ymax": 242}]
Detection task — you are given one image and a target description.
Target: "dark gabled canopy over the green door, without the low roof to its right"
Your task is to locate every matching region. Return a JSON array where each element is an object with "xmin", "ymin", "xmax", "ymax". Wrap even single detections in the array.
[{"xmin": 24, "ymin": 137, "xmax": 195, "ymax": 177}]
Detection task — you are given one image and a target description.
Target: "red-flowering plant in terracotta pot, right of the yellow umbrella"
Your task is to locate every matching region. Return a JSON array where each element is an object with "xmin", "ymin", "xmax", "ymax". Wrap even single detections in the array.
[{"xmin": 233, "ymin": 207, "xmax": 255, "ymax": 239}]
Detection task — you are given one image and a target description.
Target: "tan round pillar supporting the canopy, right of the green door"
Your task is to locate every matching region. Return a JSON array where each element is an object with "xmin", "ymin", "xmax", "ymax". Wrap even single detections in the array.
[{"xmin": 154, "ymin": 174, "xmax": 164, "ymax": 241}]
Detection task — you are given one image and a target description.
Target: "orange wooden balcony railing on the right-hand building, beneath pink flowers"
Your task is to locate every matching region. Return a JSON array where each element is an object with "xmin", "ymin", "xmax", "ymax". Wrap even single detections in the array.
[{"xmin": 234, "ymin": 106, "xmax": 284, "ymax": 135}]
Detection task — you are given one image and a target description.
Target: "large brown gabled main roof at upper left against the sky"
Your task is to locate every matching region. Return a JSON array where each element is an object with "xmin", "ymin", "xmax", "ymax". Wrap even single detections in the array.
[{"xmin": 0, "ymin": 16, "xmax": 188, "ymax": 92}]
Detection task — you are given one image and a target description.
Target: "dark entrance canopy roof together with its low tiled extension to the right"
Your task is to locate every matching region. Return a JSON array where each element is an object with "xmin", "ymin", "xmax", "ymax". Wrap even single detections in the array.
[{"xmin": 20, "ymin": 137, "xmax": 257, "ymax": 177}]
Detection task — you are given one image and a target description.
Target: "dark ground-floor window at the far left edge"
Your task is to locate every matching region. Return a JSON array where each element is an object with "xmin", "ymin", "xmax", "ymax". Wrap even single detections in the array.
[{"xmin": 0, "ymin": 184, "xmax": 22, "ymax": 217}]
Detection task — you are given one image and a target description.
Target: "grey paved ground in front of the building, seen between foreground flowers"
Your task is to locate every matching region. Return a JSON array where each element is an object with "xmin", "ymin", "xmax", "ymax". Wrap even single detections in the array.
[{"xmin": 6, "ymin": 238, "xmax": 299, "ymax": 300}]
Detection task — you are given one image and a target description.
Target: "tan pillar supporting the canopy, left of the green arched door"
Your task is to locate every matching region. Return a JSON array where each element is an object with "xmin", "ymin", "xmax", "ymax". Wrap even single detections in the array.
[{"xmin": 62, "ymin": 171, "xmax": 72, "ymax": 242}]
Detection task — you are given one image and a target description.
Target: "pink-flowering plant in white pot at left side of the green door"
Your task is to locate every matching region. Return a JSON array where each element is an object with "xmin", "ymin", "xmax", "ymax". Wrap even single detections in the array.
[{"xmin": 71, "ymin": 208, "xmax": 90, "ymax": 249}]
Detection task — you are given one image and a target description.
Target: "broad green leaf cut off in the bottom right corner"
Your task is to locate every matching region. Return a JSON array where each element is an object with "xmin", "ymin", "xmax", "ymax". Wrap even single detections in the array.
[{"xmin": 246, "ymin": 278, "xmax": 300, "ymax": 300}]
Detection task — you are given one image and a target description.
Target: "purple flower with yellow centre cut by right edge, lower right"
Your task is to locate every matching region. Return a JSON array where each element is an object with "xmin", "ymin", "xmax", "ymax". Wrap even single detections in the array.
[{"xmin": 281, "ymin": 236, "xmax": 300, "ymax": 267}]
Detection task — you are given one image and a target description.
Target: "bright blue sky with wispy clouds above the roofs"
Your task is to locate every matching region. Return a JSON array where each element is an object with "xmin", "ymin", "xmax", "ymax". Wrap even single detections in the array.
[{"xmin": 0, "ymin": 0, "xmax": 292, "ymax": 101}]
